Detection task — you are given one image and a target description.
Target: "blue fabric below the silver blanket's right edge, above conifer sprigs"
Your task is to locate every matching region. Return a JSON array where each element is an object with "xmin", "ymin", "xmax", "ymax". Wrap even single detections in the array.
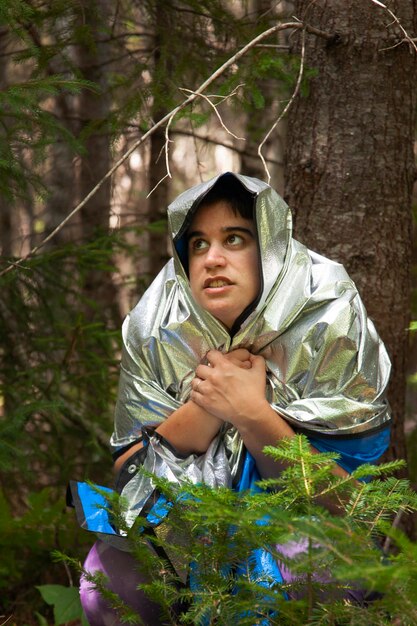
[{"xmin": 308, "ymin": 426, "xmax": 391, "ymax": 472}]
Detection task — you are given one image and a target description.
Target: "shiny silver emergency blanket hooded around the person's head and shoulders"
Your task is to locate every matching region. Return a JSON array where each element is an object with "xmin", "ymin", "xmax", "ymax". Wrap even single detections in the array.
[{"xmin": 111, "ymin": 173, "xmax": 390, "ymax": 523}]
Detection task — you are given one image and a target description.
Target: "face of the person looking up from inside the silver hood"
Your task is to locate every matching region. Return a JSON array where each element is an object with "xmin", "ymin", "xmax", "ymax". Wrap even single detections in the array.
[{"xmin": 188, "ymin": 201, "xmax": 260, "ymax": 329}]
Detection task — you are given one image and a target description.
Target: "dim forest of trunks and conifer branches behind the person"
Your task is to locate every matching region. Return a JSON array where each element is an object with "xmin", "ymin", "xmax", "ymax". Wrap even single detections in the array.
[{"xmin": 0, "ymin": 0, "xmax": 417, "ymax": 624}]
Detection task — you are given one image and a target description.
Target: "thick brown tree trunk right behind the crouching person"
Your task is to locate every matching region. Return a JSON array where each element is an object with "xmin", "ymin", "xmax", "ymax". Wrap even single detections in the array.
[{"xmin": 285, "ymin": 0, "xmax": 417, "ymax": 459}]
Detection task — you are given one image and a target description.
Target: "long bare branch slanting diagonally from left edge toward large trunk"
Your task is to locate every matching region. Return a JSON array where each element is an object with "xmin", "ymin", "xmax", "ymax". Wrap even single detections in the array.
[{"xmin": 0, "ymin": 22, "xmax": 309, "ymax": 277}]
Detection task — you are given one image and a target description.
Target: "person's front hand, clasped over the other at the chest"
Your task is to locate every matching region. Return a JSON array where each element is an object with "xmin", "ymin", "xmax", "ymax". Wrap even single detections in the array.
[{"xmin": 191, "ymin": 349, "xmax": 269, "ymax": 427}]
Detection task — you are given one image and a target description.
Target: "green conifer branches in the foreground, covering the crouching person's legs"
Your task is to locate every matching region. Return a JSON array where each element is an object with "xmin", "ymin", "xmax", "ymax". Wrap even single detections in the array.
[{"xmin": 76, "ymin": 435, "xmax": 417, "ymax": 626}]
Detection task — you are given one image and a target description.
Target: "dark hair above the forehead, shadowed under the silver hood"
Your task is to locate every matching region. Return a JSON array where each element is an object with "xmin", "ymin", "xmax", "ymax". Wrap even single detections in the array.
[{"xmin": 196, "ymin": 175, "xmax": 254, "ymax": 220}]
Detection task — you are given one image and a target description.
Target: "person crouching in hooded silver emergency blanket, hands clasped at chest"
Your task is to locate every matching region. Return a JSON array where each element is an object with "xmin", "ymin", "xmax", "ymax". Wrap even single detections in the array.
[{"xmin": 77, "ymin": 173, "xmax": 390, "ymax": 626}]
